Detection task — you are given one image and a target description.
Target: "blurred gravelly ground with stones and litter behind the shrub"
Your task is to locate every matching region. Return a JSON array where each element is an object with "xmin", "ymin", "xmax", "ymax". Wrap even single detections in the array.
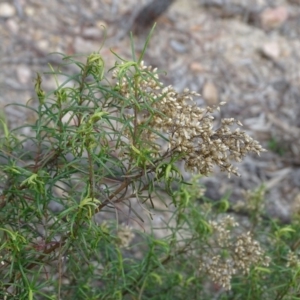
[{"xmin": 0, "ymin": 0, "xmax": 300, "ymax": 225}]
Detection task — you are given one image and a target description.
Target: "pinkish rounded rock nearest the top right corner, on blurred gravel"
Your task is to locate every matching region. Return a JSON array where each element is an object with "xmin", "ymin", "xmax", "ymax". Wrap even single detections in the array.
[{"xmin": 260, "ymin": 6, "xmax": 289, "ymax": 29}]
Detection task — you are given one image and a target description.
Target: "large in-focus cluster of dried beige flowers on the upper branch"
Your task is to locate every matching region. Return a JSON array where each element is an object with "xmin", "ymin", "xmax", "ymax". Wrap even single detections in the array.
[{"xmin": 113, "ymin": 62, "xmax": 264, "ymax": 176}]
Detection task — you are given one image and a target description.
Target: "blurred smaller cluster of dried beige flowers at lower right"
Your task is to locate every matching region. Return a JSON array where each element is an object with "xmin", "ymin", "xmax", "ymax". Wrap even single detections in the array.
[{"xmin": 200, "ymin": 216, "xmax": 270, "ymax": 290}]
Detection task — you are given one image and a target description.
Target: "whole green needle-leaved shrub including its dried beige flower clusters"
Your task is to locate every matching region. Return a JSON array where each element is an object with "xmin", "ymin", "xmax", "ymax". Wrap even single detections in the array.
[{"xmin": 0, "ymin": 29, "xmax": 299, "ymax": 299}]
